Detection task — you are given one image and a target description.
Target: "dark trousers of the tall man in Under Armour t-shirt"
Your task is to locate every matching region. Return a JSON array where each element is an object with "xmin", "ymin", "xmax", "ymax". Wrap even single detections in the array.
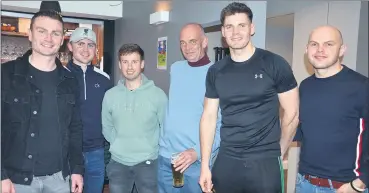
[{"xmin": 212, "ymin": 154, "xmax": 284, "ymax": 193}]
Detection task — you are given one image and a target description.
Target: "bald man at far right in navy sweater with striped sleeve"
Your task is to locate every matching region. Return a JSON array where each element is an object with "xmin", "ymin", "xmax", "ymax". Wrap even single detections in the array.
[{"xmin": 295, "ymin": 26, "xmax": 369, "ymax": 193}]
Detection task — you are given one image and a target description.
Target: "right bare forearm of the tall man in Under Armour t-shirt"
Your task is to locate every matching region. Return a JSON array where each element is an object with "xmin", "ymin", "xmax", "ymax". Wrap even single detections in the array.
[{"xmin": 280, "ymin": 114, "xmax": 299, "ymax": 157}]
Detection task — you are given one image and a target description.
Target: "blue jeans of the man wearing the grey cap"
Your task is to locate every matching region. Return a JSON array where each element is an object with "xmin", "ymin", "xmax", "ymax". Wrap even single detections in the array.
[{"xmin": 83, "ymin": 148, "xmax": 105, "ymax": 193}]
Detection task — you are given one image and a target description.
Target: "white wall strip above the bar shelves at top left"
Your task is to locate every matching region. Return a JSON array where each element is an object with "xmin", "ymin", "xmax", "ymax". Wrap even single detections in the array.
[{"xmin": 1, "ymin": 1, "xmax": 123, "ymax": 19}]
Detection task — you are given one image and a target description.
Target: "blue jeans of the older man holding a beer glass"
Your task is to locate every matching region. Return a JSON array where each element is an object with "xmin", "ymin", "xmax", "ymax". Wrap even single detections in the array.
[{"xmin": 158, "ymin": 156, "xmax": 202, "ymax": 193}]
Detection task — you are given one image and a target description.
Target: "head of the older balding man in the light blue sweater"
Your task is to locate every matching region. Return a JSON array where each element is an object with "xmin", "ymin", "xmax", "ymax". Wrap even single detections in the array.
[{"xmin": 180, "ymin": 23, "xmax": 208, "ymax": 62}]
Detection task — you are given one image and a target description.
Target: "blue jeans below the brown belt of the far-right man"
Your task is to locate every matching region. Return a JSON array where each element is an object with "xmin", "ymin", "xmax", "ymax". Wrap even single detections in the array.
[{"xmin": 296, "ymin": 173, "xmax": 368, "ymax": 193}]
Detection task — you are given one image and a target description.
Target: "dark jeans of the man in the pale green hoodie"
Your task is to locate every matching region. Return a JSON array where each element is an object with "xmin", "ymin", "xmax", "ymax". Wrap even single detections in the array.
[{"xmin": 107, "ymin": 159, "xmax": 158, "ymax": 193}]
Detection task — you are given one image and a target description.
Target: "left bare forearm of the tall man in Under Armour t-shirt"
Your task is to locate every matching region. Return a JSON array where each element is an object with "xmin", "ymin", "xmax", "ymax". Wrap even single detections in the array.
[{"xmin": 200, "ymin": 116, "xmax": 216, "ymax": 166}]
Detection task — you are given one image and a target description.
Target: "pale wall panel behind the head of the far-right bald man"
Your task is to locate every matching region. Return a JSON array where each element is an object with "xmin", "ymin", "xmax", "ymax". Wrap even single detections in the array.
[{"xmin": 292, "ymin": 1, "xmax": 361, "ymax": 83}]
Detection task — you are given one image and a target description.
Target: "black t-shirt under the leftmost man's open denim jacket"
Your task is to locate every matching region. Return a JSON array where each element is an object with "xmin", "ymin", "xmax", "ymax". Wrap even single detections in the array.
[{"xmin": 30, "ymin": 65, "xmax": 62, "ymax": 176}]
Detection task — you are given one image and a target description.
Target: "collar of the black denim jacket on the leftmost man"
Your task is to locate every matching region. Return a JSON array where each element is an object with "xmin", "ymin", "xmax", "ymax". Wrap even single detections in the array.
[{"xmin": 14, "ymin": 50, "xmax": 73, "ymax": 80}]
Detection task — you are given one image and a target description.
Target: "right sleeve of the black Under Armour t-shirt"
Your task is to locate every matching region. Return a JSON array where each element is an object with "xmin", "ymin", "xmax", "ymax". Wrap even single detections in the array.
[{"xmin": 273, "ymin": 56, "xmax": 297, "ymax": 93}]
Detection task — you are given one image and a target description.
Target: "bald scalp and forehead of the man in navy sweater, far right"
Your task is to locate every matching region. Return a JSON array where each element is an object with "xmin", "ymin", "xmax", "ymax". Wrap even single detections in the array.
[{"xmin": 309, "ymin": 25, "xmax": 343, "ymax": 45}]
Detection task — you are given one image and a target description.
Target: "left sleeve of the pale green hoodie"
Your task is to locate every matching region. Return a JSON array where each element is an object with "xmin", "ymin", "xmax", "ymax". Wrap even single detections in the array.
[{"xmin": 101, "ymin": 92, "xmax": 115, "ymax": 143}]
